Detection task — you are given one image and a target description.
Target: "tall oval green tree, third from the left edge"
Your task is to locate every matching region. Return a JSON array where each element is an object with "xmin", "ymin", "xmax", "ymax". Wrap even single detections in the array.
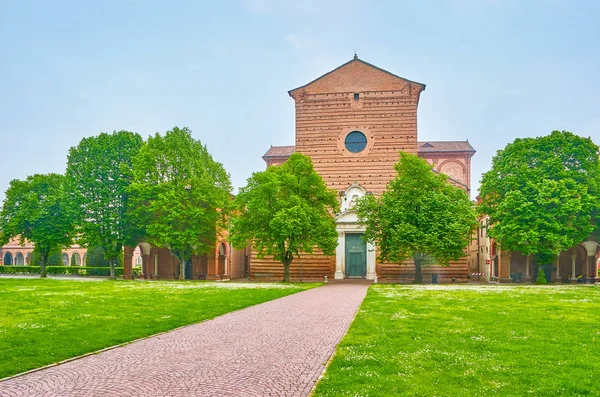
[{"xmin": 131, "ymin": 127, "xmax": 232, "ymax": 279}]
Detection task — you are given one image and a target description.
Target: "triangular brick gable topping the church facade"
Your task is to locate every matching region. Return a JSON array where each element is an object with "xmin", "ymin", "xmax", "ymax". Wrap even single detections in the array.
[{"xmin": 288, "ymin": 56, "xmax": 425, "ymax": 98}]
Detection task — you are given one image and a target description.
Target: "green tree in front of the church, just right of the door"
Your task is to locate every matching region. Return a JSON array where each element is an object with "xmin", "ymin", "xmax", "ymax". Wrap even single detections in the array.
[{"xmin": 357, "ymin": 152, "xmax": 477, "ymax": 283}]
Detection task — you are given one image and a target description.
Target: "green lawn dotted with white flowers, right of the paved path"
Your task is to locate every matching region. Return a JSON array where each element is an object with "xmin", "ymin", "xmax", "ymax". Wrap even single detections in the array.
[{"xmin": 315, "ymin": 285, "xmax": 600, "ymax": 396}]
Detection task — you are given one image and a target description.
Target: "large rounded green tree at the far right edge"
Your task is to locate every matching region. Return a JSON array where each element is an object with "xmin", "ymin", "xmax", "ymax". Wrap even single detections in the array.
[{"xmin": 479, "ymin": 131, "xmax": 600, "ymax": 279}]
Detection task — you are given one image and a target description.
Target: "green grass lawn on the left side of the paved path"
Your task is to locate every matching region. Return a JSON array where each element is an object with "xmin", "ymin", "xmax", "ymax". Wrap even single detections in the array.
[{"xmin": 0, "ymin": 278, "xmax": 320, "ymax": 379}]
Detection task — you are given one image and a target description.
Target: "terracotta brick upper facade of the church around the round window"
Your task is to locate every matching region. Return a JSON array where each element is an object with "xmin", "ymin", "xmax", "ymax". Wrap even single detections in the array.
[{"xmin": 289, "ymin": 59, "xmax": 425, "ymax": 194}]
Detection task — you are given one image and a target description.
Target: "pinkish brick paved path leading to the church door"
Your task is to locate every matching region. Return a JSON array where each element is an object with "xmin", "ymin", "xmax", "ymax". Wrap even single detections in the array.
[{"xmin": 0, "ymin": 284, "xmax": 368, "ymax": 397}]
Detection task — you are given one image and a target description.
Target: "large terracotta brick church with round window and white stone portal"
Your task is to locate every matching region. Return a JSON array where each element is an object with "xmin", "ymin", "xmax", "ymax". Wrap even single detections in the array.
[{"xmin": 249, "ymin": 55, "xmax": 475, "ymax": 282}]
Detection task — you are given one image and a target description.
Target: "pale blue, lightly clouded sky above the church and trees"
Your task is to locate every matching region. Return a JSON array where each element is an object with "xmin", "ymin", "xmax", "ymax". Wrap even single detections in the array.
[{"xmin": 0, "ymin": 0, "xmax": 600, "ymax": 200}]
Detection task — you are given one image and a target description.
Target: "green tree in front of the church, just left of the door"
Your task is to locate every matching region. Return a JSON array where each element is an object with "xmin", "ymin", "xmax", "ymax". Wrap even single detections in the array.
[{"xmin": 231, "ymin": 153, "xmax": 339, "ymax": 282}]
